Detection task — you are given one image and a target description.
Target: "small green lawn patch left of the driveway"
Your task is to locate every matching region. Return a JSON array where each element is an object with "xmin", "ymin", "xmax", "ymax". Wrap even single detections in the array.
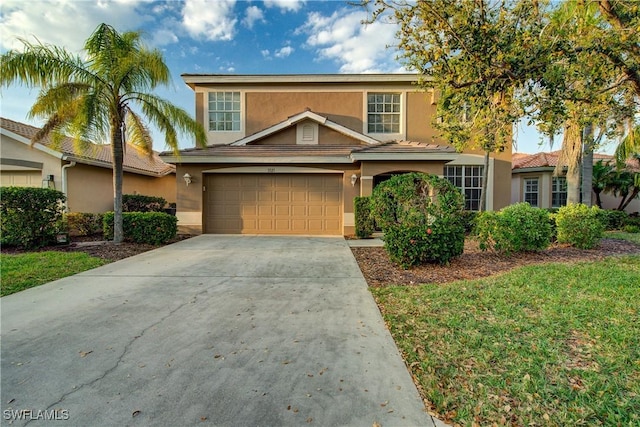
[{"xmin": 0, "ymin": 251, "xmax": 107, "ymax": 296}]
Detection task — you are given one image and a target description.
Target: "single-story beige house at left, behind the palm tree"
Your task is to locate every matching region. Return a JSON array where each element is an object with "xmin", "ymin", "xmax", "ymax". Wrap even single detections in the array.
[{"xmin": 0, "ymin": 118, "xmax": 176, "ymax": 213}]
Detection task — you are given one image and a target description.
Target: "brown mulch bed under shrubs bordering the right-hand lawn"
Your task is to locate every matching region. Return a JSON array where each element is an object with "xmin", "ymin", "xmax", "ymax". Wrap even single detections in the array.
[{"xmin": 351, "ymin": 239, "xmax": 640, "ymax": 287}]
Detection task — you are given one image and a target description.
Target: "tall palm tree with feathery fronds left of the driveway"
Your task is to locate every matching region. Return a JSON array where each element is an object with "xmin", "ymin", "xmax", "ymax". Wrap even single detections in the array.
[{"xmin": 0, "ymin": 24, "xmax": 206, "ymax": 243}]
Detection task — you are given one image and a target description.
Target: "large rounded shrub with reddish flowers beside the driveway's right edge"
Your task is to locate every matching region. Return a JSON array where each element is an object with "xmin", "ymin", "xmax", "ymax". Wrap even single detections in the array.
[{"xmin": 371, "ymin": 172, "xmax": 465, "ymax": 268}]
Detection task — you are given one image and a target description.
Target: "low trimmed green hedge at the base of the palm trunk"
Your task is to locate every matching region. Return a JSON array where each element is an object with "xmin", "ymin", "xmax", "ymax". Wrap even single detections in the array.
[{"xmin": 103, "ymin": 212, "xmax": 178, "ymax": 245}]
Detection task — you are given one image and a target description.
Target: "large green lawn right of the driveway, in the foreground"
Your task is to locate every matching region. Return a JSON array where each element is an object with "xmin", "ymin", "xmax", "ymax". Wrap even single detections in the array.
[{"xmin": 371, "ymin": 255, "xmax": 640, "ymax": 426}]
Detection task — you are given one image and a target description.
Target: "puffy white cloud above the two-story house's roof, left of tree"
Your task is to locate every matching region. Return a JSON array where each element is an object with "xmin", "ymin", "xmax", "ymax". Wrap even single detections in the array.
[{"xmin": 297, "ymin": 9, "xmax": 403, "ymax": 74}]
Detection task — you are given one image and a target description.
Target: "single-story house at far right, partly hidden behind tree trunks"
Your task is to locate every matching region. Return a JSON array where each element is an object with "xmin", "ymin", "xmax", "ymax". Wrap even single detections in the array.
[{"xmin": 511, "ymin": 151, "xmax": 640, "ymax": 213}]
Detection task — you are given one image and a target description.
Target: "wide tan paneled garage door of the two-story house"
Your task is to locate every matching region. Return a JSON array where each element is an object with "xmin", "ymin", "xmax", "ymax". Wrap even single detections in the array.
[{"xmin": 205, "ymin": 174, "xmax": 342, "ymax": 235}]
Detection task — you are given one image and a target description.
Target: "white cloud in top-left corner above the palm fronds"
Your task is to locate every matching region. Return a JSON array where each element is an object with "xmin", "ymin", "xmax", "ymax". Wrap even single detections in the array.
[{"xmin": 0, "ymin": 0, "xmax": 153, "ymax": 52}]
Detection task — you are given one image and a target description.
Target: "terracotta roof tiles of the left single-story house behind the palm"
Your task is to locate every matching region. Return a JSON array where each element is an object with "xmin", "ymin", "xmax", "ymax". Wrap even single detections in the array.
[{"xmin": 0, "ymin": 117, "xmax": 175, "ymax": 176}]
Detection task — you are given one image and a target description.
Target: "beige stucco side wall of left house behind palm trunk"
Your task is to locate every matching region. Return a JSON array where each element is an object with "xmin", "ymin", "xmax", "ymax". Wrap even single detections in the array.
[{"xmin": 67, "ymin": 164, "xmax": 176, "ymax": 213}]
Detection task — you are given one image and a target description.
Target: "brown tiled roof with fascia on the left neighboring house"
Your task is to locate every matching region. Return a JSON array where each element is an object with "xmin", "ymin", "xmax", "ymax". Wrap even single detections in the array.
[{"xmin": 0, "ymin": 117, "xmax": 176, "ymax": 176}]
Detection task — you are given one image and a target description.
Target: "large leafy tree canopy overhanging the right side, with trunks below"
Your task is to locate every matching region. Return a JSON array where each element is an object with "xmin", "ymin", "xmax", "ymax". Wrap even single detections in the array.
[{"xmin": 362, "ymin": 0, "xmax": 640, "ymax": 209}]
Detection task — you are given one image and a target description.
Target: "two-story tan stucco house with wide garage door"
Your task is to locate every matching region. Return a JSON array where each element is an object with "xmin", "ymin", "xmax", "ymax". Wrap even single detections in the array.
[{"xmin": 161, "ymin": 74, "xmax": 511, "ymax": 235}]
